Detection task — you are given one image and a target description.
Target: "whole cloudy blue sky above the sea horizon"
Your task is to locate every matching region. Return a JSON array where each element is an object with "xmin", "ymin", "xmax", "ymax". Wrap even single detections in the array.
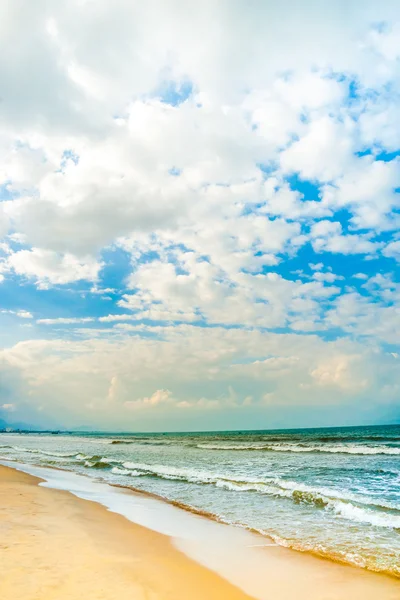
[{"xmin": 0, "ymin": 0, "xmax": 400, "ymax": 431}]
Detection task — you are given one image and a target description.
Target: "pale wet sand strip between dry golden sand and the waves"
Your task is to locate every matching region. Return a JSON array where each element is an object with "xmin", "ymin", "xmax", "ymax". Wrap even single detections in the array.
[{"xmin": 0, "ymin": 463, "xmax": 400, "ymax": 600}]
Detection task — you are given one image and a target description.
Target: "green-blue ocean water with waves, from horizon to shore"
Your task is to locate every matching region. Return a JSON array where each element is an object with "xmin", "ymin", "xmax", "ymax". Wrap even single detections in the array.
[{"xmin": 0, "ymin": 425, "xmax": 400, "ymax": 577}]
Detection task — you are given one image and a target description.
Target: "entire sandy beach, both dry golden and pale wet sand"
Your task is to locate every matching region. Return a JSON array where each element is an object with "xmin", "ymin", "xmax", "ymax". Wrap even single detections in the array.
[{"xmin": 0, "ymin": 466, "xmax": 400, "ymax": 600}]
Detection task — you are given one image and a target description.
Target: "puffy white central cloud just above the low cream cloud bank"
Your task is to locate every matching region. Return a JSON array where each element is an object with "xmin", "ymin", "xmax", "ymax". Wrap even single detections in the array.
[{"xmin": 119, "ymin": 253, "xmax": 340, "ymax": 329}]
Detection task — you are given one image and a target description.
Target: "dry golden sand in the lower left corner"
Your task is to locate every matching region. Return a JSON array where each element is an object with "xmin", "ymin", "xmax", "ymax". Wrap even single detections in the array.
[{"xmin": 0, "ymin": 467, "xmax": 252, "ymax": 600}]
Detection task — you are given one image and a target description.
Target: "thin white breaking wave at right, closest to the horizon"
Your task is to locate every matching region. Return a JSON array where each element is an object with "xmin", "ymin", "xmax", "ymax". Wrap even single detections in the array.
[{"xmin": 196, "ymin": 444, "xmax": 400, "ymax": 456}]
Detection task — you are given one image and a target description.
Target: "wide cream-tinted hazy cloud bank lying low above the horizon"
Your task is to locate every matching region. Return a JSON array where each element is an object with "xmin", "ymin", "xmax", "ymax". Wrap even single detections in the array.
[{"xmin": 0, "ymin": 325, "xmax": 398, "ymax": 430}]
